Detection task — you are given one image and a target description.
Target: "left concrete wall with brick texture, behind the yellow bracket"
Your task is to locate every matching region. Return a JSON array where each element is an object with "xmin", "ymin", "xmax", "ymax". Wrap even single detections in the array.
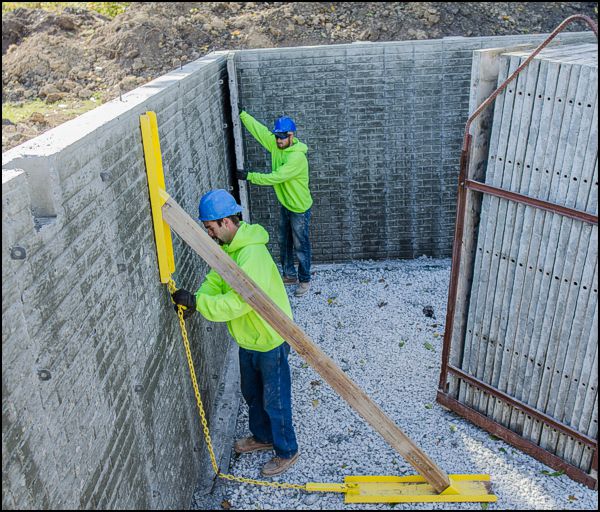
[{"xmin": 2, "ymin": 54, "xmax": 237, "ymax": 509}]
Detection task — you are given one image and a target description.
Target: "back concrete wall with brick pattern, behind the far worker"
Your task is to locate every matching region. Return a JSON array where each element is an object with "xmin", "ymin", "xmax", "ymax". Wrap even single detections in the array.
[{"xmin": 236, "ymin": 32, "xmax": 595, "ymax": 262}]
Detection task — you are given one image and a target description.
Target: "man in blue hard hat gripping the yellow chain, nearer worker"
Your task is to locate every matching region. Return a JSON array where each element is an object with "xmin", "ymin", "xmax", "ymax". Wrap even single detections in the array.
[{"xmin": 172, "ymin": 189, "xmax": 299, "ymax": 477}]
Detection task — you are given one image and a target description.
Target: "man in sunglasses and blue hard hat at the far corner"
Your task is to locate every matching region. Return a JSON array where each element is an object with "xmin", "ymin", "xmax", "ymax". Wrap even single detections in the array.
[{"xmin": 237, "ymin": 111, "xmax": 313, "ymax": 297}]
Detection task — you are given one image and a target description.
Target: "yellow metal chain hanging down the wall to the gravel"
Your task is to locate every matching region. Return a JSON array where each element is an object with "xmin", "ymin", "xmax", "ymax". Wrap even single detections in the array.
[{"xmin": 167, "ymin": 278, "xmax": 306, "ymax": 491}]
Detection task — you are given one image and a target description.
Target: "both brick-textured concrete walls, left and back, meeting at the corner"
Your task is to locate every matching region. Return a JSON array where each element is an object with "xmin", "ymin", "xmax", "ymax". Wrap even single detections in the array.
[{"xmin": 2, "ymin": 34, "xmax": 593, "ymax": 509}]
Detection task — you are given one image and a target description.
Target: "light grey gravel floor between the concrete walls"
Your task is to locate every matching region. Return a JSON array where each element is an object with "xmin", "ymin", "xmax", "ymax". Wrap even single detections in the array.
[{"xmin": 200, "ymin": 257, "xmax": 598, "ymax": 510}]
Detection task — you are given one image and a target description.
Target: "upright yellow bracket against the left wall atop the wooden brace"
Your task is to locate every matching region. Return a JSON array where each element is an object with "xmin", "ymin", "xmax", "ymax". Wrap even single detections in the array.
[{"xmin": 140, "ymin": 112, "xmax": 175, "ymax": 284}]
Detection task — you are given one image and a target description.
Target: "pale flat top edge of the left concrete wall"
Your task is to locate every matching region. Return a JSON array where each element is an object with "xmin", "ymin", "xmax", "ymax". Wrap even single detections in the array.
[{"xmin": 2, "ymin": 52, "xmax": 228, "ymax": 170}]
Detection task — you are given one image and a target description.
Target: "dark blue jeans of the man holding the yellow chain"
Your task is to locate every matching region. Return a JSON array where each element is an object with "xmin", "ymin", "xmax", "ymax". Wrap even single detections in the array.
[{"xmin": 240, "ymin": 342, "xmax": 298, "ymax": 459}]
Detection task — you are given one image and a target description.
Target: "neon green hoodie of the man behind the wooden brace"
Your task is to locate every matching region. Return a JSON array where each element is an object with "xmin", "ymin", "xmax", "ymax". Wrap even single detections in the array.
[{"xmin": 196, "ymin": 222, "xmax": 293, "ymax": 352}]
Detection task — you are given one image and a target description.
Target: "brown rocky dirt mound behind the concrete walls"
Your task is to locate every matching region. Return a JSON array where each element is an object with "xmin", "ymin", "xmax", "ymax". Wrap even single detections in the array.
[{"xmin": 2, "ymin": 2, "xmax": 597, "ymax": 151}]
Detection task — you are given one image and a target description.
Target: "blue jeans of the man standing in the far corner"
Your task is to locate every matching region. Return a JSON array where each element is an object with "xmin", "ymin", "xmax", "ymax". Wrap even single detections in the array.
[{"xmin": 279, "ymin": 205, "xmax": 310, "ymax": 283}]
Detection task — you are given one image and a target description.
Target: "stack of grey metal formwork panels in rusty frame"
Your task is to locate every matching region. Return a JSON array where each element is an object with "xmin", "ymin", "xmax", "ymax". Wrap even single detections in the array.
[{"xmin": 441, "ymin": 45, "xmax": 598, "ymax": 484}]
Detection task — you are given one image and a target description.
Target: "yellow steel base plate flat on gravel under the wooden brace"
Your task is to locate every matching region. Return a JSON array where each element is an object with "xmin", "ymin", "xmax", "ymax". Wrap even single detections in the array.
[{"xmin": 344, "ymin": 475, "xmax": 498, "ymax": 503}]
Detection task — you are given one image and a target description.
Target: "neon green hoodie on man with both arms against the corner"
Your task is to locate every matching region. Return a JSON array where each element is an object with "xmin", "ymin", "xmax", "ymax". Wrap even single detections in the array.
[{"xmin": 240, "ymin": 111, "xmax": 313, "ymax": 213}]
